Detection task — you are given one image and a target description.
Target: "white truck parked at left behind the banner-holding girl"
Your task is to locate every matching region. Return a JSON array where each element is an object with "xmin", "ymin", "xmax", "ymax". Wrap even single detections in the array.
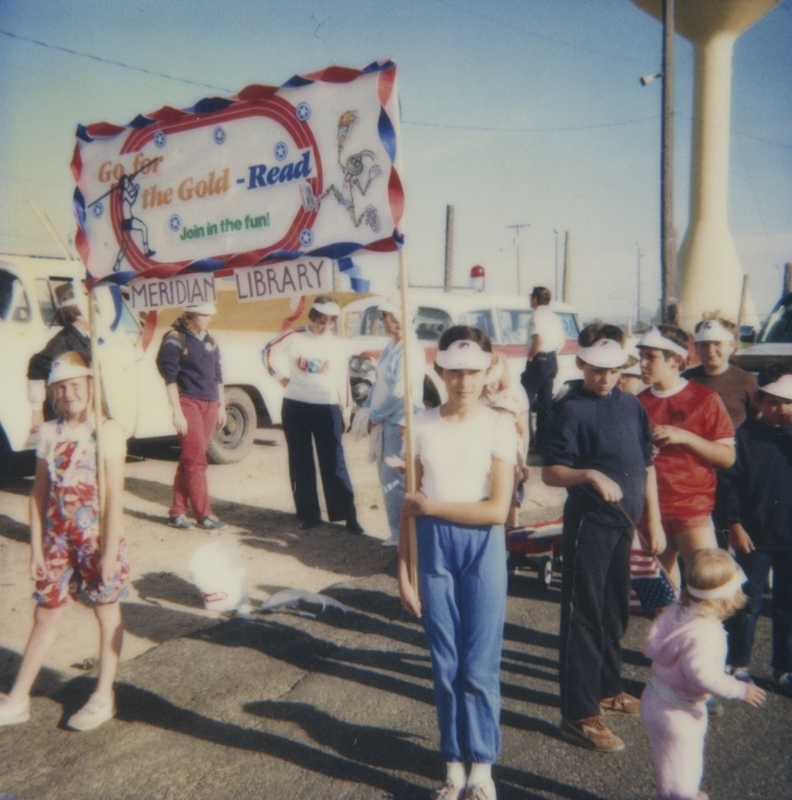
[{"xmin": 0, "ymin": 254, "xmax": 283, "ymax": 473}]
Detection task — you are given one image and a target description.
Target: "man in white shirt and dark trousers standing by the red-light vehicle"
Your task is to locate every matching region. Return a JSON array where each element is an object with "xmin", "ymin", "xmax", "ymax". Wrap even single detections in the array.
[{"xmin": 520, "ymin": 286, "xmax": 566, "ymax": 448}]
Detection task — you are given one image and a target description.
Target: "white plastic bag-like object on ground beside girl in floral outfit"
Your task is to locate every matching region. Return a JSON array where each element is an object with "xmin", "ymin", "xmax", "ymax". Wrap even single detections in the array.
[{"xmin": 190, "ymin": 539, "xmax": 248, "ymax": 611}]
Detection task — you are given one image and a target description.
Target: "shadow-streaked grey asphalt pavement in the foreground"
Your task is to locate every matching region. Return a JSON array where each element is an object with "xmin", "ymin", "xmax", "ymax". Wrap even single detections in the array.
[{"xmin": 0, "ymin": 548, "xmax": 792, "ymax": 800}]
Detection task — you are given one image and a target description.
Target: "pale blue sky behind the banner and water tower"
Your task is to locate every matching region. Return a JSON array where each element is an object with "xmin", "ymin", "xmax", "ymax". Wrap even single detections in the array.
[{"xmin": 0, "ymin": 0, "xmax": 792, "ymax": 319}]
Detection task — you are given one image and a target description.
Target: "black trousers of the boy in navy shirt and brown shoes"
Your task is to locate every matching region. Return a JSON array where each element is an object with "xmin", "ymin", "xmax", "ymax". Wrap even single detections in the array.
[{"xmin": 559, "ymin": 515, "xmax": 632, "ymax": 720}]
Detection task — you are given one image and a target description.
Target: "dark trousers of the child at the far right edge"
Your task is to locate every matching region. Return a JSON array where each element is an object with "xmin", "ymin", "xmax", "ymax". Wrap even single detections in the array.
[{"xmin": 724, "ymin": 550, "xmax": 792, "ymax": 672}]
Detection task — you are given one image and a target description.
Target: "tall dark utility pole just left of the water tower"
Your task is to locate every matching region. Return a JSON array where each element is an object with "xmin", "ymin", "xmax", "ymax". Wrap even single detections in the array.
[{"xmin": 660, "ymin": 0, "xmax": 679, "ymax": 322}]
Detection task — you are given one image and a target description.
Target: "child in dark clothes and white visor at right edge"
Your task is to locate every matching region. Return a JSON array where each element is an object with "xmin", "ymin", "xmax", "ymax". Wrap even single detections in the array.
[{"xmin": 723, "ymin": 364, "xmax": 792, "ymax": 692}]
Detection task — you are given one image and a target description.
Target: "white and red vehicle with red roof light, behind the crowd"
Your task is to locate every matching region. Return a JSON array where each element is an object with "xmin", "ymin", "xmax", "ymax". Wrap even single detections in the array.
[{"xmin": 339, "ymin": 289, "xmax": 581, "ymax": 406}]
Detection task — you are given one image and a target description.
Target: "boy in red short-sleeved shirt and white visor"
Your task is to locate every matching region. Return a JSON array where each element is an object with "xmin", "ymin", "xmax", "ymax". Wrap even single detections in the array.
[{"xmin": 638, "ymin": 325, "xmax": 734, "ymax": 586}]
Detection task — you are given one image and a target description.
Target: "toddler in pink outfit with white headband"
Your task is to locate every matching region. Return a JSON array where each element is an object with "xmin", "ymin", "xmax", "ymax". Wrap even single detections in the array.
[{"xmin": 641, "ymin": 549, "xmax": 765, "ymax": 800}]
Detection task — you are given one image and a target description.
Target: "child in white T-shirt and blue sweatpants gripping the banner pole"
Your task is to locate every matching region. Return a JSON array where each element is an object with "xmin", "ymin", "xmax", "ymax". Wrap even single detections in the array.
[{"xmin": 399, "ymin": 325, "xmax": 516, "ymax": 800}]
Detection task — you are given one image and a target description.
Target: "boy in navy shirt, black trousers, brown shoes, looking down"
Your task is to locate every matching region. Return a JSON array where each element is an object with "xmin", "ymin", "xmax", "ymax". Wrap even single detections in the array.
[{"xmin": 542, "ymin": 325, "xmax": 665, "ymax": 752}]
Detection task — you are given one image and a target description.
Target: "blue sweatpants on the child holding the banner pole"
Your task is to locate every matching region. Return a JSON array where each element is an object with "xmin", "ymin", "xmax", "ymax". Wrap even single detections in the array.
[{"xmin": 417, "ymin": 517, "xmax": 506, "ymax": 764}]
